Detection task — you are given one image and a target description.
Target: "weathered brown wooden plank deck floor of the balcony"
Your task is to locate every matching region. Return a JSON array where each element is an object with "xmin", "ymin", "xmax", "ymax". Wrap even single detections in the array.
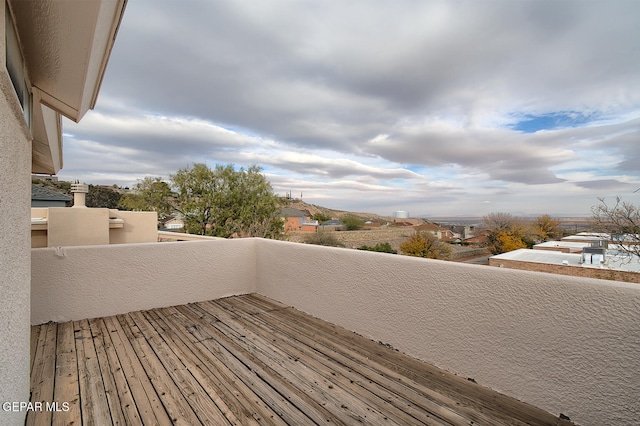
[{"xmin": 27, "ymin": 294, "xmax": 569, "ymax": 425}]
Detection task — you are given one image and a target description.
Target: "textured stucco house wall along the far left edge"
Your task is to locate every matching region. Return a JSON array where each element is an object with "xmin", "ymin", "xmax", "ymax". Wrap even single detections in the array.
[{"xmin": 0, "ymin": 22, "xmax": 31, "ymax": 425}]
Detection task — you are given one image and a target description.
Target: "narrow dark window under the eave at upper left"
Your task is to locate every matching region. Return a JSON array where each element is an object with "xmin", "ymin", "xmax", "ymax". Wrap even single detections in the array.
[{"xmin": 4, "ymin": 2, "xmax": 32, "ymax": 128}]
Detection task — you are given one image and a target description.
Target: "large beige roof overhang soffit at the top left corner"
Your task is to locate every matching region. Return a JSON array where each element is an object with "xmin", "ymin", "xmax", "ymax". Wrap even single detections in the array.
[{"xmin": 9, "ymin": 0, "xmax": 126, "ymax": 122}]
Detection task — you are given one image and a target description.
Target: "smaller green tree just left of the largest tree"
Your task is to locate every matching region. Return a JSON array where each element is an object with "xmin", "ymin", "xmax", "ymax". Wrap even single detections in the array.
[{"xmin": 119, "ymin": 177, "xmax": 173, "ymax": 220}]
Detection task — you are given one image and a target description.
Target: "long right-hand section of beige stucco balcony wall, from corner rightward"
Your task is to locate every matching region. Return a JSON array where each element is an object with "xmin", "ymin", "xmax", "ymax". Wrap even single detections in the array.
[{"xmin": 257, "ymin": 240, "xmax": 640, "ymax": 425}]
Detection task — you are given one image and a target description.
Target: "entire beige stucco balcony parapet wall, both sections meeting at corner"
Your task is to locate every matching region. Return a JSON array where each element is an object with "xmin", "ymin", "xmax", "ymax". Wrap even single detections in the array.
[{"xmin": 31, "ymin": 239, "xmax": 640, "ymax": 425}]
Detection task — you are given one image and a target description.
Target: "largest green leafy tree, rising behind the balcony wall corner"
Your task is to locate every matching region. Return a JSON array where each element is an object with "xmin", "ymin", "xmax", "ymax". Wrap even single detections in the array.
[{"xmin": 171, "ymin": 163, "xmax": 282, "ymax": 238}]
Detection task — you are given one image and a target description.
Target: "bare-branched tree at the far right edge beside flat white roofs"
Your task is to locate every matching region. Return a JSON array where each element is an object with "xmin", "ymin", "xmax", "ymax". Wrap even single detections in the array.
[{"xmin": 591, "ymin": 197, "xmax": 640, "ymax": 262}]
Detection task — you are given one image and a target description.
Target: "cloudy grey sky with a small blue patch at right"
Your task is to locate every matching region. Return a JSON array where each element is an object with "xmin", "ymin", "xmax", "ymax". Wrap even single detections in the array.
[{"xmin": 60, "ymin": 0, "xmax": 640, "ymax": 216}]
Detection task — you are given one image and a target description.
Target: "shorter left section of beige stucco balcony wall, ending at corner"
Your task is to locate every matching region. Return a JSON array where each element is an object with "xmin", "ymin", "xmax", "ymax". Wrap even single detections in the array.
[{"xmin": 27, "ymin": 239, "xmax": 256, "ymax": 322}]
